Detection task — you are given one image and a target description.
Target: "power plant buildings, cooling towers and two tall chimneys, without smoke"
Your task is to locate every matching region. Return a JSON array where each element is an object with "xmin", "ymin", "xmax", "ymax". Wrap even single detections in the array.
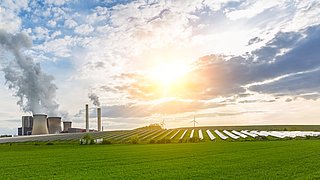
[{"xmin": 18, "ymin": 104, "xmax": 102, "ymax": 136}]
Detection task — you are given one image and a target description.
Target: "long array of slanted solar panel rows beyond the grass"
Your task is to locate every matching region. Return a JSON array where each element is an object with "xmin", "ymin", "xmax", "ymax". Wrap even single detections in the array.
[{"xmin": 0, "ymin": 128, "xmax": 320, "ymax": 143}]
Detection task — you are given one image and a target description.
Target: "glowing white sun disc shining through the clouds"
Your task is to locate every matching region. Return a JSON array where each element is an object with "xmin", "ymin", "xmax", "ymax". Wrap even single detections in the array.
[{"xmin": 149, "ymin": 62, "xmax": 190, "ymax": 87}]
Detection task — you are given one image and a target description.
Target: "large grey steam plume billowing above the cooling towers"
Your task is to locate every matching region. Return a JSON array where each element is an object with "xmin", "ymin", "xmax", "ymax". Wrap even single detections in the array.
[{"xmin": 0, "ymin": 30, "xmax": 59, "ymax": 116}]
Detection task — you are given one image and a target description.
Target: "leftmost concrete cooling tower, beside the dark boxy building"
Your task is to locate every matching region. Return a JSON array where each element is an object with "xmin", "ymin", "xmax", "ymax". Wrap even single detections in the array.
[{"xmin": 32, "ymin": 114, "xmax": 48, "ymax": 135}]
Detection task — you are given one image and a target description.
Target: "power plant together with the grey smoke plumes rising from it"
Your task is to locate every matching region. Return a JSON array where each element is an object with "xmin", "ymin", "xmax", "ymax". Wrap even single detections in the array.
[{"xmin": 0, "ymin": 31, "xmax": 101, "ymax": 136}]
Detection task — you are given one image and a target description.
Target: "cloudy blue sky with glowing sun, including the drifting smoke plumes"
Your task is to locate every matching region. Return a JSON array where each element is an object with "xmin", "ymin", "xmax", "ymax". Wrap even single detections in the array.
[{"xmin": 0, "ymin": 0, "xmax": 320, "ymax": 134}]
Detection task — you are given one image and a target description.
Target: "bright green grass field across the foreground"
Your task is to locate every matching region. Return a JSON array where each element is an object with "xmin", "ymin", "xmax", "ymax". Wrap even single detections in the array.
[{"xmin": 0, "ymin": 140, "xmax": 320, "ymax": 179}]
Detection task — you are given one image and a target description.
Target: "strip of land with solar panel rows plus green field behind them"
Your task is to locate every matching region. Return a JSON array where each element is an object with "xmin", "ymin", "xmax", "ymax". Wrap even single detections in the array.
[{"xmin": 0, "ymin": 126, "xmax": 320, "ymax": 144}]
